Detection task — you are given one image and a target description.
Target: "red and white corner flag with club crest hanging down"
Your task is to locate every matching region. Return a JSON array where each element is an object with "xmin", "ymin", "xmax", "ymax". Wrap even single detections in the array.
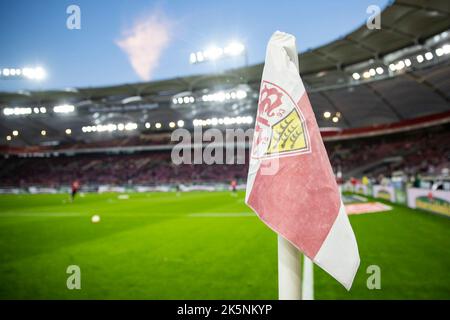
[{"xmin": 245, "ymin": 32, "xmax": 359, "ymax": 290}]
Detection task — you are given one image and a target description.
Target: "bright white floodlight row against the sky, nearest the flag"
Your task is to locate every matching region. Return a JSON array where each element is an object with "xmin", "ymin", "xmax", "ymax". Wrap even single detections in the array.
[{"xmin": 189, "ymin": 41, "xmax": 246, "ymax": 64}]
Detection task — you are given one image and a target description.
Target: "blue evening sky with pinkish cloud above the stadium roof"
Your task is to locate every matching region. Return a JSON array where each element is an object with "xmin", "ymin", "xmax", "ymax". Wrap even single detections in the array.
[{"xmin": 0, "ymin": 0, "xmax": 389, "ymax": 91}]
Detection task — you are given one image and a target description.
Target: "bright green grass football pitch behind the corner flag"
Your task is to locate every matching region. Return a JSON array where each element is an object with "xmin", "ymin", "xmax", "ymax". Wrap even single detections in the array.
[{"xmin": 0, "ymin": 192, "xmax": 450, "ymax": 299}]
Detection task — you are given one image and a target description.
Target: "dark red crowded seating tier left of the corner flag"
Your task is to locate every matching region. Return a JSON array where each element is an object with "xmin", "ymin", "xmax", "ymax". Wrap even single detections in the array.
[{"xmin": 0, "ymin": 152, "xmax": 247, "ymax": 187}]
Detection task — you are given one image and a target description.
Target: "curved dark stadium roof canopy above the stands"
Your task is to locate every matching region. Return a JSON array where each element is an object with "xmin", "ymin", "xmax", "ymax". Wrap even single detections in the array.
[{"xmin": 0, "ymin": 0, "xmax": 450, "ymax": 143}]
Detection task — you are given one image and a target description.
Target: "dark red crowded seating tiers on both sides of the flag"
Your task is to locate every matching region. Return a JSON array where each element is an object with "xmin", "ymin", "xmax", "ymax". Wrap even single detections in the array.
[{"xmin": 0, "ymin": 125, "xmax": 450, "ymax": 187}]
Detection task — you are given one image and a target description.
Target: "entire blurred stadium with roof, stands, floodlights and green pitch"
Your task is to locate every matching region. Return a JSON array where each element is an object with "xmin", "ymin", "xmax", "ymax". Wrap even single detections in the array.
[{"xmin": 0, "ymin": 0, "xmax": 450, "ymax": 300}]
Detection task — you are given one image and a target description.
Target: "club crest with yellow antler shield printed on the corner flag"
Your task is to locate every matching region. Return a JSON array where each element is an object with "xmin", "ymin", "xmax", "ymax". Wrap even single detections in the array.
[{"xmin": 252, "ymin": 81, "xmax": 310, "ymax": 159}]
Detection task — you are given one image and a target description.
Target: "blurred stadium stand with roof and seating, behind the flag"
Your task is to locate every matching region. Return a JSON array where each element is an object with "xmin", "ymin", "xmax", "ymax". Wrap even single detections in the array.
[{"xmin": 0, "ymin": 0, "xmax": 450, "ymax": 187}]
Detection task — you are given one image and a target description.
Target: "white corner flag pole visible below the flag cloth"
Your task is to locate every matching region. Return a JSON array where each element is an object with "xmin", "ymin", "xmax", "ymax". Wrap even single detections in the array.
[{"xmin": 278, "ymin": 235, "xmax": 302, "ymax": 300}]
